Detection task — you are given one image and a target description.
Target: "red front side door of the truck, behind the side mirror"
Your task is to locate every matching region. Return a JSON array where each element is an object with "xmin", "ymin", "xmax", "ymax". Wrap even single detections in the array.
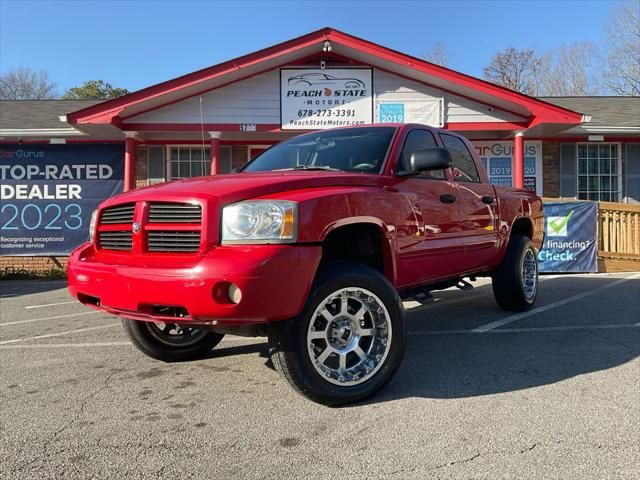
[{"xmin": 395, "ymin": 129, "xmax": 464, "ymax": 286}]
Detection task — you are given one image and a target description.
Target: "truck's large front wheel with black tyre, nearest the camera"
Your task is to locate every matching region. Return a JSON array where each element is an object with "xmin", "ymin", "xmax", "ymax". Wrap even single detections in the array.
[{"xmin": 269, "ymin": 263, "xmax": 406, "ymax": 406}]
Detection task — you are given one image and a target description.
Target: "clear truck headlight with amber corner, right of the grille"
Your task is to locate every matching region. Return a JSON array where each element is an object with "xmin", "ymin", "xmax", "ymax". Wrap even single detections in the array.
[{"xmin": 222, "ymin": 200, "xmax": 297, "ymax": 243}]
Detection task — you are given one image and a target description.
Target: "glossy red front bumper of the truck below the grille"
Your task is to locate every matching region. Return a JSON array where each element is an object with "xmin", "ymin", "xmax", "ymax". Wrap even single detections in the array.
[{"xmin": 67, "ymin": 244, "xmax": 321, "ymax": 326}]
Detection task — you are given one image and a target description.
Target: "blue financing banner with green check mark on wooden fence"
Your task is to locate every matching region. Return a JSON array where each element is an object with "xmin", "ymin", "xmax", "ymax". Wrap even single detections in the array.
[{"xmin": 538, "ymin": 202, "xmax": 598, "ymax": 273}]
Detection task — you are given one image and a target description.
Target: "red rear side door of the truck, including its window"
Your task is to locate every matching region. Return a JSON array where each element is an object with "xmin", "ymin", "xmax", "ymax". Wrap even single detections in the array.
[{"xmin": 440, "ymin": 133, "xmax": 498, "ymax": 271}]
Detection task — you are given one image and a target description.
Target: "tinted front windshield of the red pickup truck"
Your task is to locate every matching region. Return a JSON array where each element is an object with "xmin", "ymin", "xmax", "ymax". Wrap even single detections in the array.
[{"xmin": 242, "ymin": 127, "xmax": 396, "ymax": 173}]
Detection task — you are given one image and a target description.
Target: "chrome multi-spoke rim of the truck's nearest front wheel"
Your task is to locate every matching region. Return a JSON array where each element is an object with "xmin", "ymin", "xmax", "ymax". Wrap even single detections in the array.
[{"xmin": 307, "ymin": 287, "xmax": 392, "ymax": 386}]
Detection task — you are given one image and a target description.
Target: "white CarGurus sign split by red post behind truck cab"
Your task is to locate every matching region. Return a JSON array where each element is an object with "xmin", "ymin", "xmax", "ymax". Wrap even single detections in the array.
[{"xmin": 472, "ymin": 141, "xmax": 542, "ymax": 195}]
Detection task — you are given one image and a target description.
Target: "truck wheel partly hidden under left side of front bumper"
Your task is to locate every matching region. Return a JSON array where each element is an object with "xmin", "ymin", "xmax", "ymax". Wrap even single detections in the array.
[{"xmin": 122, "ymin": 318, "xmax": 224, "ymax": 362}]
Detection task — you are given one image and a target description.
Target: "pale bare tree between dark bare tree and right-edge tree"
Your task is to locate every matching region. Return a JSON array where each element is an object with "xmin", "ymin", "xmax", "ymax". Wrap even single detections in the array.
[{"xmin": 537, "ymin": 42, "xmax": 602, "ymax": 96}]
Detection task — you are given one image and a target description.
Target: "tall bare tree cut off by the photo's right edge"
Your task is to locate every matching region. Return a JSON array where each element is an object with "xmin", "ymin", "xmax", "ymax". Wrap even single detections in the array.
[{"xmin": 605, "ymin": 0, "xmax": 640, "ymax": 96}]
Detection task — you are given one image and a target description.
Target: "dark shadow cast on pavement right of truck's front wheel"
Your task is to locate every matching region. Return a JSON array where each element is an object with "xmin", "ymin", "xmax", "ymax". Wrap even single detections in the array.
[{"xmin": 366, "ymin": 277, "xmax": 640, "ymax": 403}]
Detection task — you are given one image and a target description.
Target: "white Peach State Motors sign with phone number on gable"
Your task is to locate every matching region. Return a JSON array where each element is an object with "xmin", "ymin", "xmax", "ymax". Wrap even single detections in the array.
[{"xmin": 280, "ymin": 68, "xmax": 373, "ymax": 130}]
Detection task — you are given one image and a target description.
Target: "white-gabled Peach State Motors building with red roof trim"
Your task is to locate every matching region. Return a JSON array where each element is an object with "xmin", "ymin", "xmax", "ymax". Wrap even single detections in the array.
[{"xmin": 0, "ymin": 28, "xmax": 640, "ymax": 270}]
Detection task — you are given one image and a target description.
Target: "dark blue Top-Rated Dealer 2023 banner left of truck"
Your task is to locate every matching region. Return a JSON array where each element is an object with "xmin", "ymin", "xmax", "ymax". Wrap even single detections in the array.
[{"xmin": 0, "ymin": 145, "xmax": 124, "ymax": 255}]
